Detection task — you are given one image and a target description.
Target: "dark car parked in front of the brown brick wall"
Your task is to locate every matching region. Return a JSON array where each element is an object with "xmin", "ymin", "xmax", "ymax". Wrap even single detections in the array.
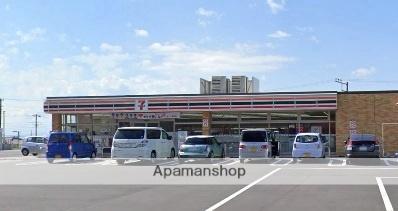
[{"xmin": 345, "ymin": 134, "xmax": 380, "ymax": 158}]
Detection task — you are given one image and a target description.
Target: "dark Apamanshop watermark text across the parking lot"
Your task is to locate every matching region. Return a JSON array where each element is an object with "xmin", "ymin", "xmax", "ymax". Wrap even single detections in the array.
[{"xmin": 153, "ymin": 165, "xmax": 246, "ymax": 179}]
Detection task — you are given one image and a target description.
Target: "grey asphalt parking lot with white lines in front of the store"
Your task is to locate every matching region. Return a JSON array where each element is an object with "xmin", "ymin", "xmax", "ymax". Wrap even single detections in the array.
[{"xmin": 0, "ymin": 151, "xmax": 398, "ymax": 211}]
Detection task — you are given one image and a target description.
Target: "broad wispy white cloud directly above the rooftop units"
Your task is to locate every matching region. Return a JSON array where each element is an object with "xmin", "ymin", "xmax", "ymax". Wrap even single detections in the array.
[{"xmin": 145, "ymin": 43, "xmax": 294, "ymax": 75}]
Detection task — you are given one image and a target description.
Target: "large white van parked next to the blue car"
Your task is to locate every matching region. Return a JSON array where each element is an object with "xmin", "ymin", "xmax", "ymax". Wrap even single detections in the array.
[{"xmin": 111, "ymin": 127, "xmax": 176, "ymax": 164}]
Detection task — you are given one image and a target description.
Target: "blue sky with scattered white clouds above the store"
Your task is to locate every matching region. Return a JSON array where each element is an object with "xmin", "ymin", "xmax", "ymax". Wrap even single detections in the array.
[{"xmin": 0, "ymin": 0, "xmax": 398, "ymax": 135}]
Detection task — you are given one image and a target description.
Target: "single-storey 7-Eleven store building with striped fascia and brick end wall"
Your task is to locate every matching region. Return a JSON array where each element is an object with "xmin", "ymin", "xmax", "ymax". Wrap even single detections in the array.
[{"xmin": 44, "ymin": 90, "xmax": 398, "ymax": 155}]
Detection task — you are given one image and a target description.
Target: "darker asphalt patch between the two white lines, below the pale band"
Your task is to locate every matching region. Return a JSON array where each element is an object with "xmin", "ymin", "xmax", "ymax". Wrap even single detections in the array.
[{"xmin": 213, "ymin": 185, "xmax": 385, "ymax": 211}]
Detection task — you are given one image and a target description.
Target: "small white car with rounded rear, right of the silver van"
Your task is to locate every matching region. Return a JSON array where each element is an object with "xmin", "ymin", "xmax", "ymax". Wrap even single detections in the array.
[{"xmin": 292, "ymin": 133, "xmax": 326, "ymax": 158}]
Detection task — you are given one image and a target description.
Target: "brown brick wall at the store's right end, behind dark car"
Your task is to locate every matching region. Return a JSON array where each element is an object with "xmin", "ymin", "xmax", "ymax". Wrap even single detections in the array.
[{"xmin": 336, "ymin": 91, "xmax": 398, "ymax": 155}]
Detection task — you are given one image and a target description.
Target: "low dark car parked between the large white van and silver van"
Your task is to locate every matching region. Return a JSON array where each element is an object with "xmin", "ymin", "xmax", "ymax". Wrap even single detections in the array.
[{"xmin": 178, "ymin": 136, "xmax": 225, "ymax": 158}]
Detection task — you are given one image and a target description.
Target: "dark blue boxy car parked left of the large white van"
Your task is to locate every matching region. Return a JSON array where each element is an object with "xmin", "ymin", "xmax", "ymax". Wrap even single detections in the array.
[{"xmin": 46, "ymin": 132, "xmax": 97, "ymax": 163}]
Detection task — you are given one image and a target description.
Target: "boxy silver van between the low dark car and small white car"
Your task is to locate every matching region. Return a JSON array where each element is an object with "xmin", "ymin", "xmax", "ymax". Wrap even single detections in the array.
[{"xmin": 239, "ymin": 129, "xmax": 272, "ymax": 163}]
